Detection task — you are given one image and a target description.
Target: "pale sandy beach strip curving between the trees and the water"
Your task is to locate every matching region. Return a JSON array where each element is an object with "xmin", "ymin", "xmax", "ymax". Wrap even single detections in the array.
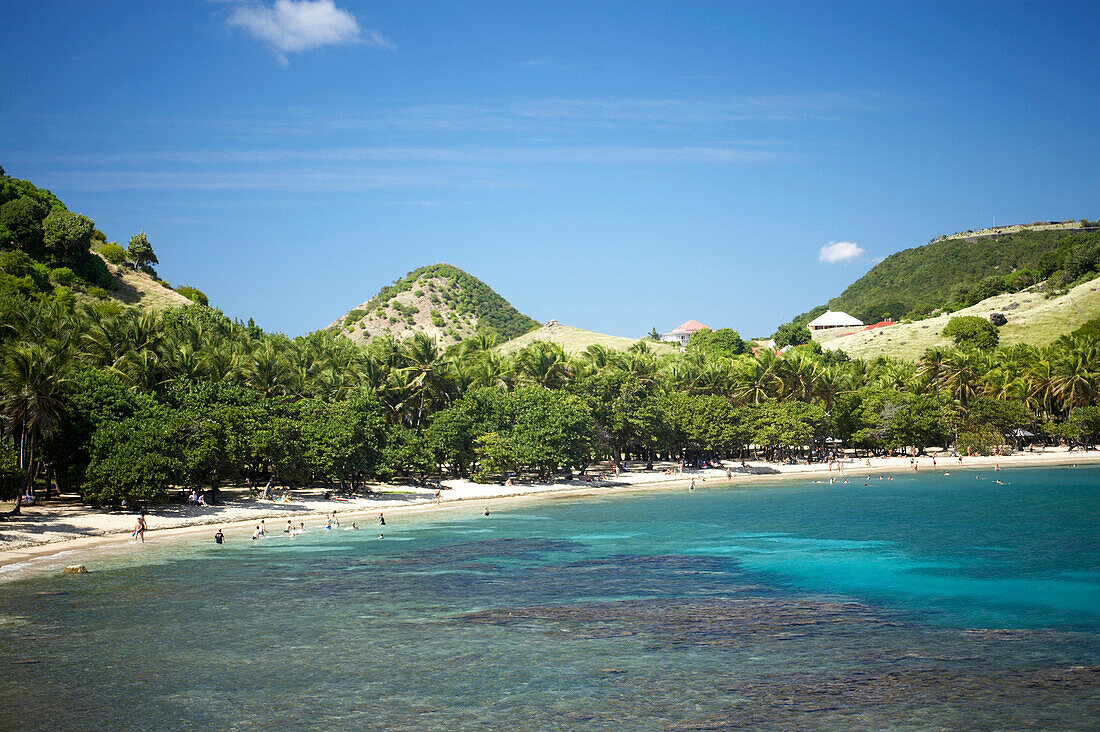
[{"xmin": 0, "ymin": 448, "xmax": 1100, "ymax": 579}]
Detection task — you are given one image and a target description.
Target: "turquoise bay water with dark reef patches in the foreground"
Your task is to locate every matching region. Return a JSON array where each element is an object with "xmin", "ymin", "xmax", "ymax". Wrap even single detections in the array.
[{"xmin": 0, "ymin": 468, "xmax": 1100, "ymax": 730}]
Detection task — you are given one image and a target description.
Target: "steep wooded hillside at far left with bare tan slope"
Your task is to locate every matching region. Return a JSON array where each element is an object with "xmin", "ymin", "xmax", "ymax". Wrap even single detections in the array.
[{"xmin": 0, "ymin": 168, "xmax": 195, "ymax": 308}]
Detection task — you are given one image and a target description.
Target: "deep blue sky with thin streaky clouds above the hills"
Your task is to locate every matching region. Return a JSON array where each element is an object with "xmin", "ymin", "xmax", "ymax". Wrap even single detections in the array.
[{"xmin": 0, "ymin": 0, "xmax": 1100, "ymax": 337}]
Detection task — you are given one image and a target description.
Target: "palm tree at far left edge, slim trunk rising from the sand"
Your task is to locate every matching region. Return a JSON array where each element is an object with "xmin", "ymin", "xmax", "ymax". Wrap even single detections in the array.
[{"xmin": 0, "ymin": 343, "xmax": 69, "ymax": 515}]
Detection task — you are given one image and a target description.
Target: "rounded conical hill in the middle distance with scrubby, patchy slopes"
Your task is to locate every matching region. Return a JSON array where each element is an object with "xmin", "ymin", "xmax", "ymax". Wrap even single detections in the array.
[{"xmin": 329, "ymin": 263, "xmax": 539, "ymax": 348}]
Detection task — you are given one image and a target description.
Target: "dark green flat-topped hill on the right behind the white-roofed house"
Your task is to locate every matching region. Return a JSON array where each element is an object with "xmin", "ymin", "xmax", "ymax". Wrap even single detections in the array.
[{"xmin": 796, "ymin": 222, "xmax": 1100, "ymax": 323}]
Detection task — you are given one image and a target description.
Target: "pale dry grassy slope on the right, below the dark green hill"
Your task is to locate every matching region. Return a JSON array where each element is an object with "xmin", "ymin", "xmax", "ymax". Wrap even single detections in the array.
[{"xmin": 816, "ymin": 270, "xmax": 1100, "ymax": 360}]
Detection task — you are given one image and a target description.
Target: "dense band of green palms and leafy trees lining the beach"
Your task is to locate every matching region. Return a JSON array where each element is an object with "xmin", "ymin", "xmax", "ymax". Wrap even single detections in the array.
[{"xmin": 0, "ymin": 294, "xmax": 1100, "ymax": 512}]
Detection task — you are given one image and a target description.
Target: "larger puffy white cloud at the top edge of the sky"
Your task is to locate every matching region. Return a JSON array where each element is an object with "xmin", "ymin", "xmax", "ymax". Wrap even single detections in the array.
[{"xmin": 227, "ymin": 0, "xmax": 394, "ymax": 64}]
